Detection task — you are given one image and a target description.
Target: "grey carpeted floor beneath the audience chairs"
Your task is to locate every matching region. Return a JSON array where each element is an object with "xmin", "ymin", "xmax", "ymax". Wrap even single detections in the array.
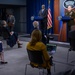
[{"xmin": 0, "ymin": 38, "xmax": 75, "ymax": 75}]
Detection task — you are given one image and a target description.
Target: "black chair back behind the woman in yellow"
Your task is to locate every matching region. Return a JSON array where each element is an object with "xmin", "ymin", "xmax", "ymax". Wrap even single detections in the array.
[{"xmin": 27, "ymin": 49, "xmax": 44, "ymax": 65}]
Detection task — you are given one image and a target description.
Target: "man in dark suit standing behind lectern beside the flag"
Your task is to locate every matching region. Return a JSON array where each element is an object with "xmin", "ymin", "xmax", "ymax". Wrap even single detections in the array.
[{"xmin": 38, "ymin": 5, "xmax": 48, "ymax": 35}]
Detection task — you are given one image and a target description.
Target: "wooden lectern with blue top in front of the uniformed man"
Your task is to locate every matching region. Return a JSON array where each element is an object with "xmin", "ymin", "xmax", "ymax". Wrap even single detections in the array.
[{"xmin": 58, "ymin": 16, "xmax": 71, "ymax": 42}]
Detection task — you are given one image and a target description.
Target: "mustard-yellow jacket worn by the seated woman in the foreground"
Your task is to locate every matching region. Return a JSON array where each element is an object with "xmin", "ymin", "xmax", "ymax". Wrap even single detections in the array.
[{"xmin": 27, "ymin": 42, "xmax": 50, "ymax": 69}]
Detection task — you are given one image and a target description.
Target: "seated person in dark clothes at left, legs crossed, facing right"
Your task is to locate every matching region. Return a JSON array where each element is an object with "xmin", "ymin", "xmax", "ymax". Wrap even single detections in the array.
[{"xmin": 2, "ymin": 20, "xmax": 22, "ymax": 48}]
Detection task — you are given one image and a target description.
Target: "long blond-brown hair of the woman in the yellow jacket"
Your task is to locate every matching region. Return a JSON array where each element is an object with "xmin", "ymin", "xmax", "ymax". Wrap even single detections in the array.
[{"xmin": 30, "ymin": 29, "xmax": 42, "ymax": 45}]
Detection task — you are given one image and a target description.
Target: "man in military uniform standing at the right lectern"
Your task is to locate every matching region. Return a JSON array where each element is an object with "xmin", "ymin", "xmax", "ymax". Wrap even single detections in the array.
[{"xmin": 65, "ymin": 5, "xmax": 75, "ymax": 31}]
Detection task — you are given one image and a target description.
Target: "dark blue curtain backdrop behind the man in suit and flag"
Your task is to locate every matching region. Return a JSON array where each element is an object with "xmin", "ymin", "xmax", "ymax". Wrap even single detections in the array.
[{"xmin": 27, "ymin": 0, "xmax": 54, "ymax": 34}]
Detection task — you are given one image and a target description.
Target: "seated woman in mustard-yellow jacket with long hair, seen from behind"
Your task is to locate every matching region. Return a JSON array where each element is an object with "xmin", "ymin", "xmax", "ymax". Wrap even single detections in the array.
[{"xmin": 27, "ymin": 29, "xmax": 52, "ymax": 75}]
